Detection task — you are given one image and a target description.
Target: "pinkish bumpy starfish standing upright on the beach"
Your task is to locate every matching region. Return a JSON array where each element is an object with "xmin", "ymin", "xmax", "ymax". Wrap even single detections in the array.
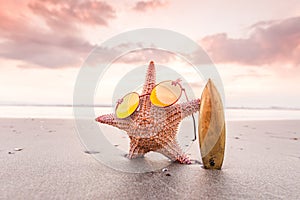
[{"xmin": 96, "ymin": 61, "xmax": 200, "ymax": 164}]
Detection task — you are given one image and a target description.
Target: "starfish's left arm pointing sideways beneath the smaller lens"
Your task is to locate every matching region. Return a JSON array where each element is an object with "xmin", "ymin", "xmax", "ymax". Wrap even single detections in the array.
[{"xmin": 95, "ymin": 114, "xmax": 130, "ymax": 131}]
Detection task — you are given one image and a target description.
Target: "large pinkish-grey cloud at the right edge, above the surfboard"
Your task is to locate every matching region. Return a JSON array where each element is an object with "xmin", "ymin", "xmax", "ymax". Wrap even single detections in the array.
[{"xmin": 201, "ymin": 17, "xmax": 300, "ymax": 66}]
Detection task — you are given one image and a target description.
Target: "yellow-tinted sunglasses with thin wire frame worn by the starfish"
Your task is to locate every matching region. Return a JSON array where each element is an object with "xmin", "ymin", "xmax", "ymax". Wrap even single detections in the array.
[{"xmin": 115, "ymin": 79, "xmax": 196, "ymax": 141}]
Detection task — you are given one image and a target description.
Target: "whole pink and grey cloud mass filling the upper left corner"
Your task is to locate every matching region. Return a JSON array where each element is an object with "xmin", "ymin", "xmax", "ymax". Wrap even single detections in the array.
[{"xmin": 0, "ymin": 0, "xmax": 114, "ymax": 68}]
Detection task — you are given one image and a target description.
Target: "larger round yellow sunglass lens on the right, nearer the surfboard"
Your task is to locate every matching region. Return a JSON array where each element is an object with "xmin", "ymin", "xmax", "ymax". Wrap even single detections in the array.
[{"xmin": 150, "ymin": 81, "xmax": 181, "ymax": 107}]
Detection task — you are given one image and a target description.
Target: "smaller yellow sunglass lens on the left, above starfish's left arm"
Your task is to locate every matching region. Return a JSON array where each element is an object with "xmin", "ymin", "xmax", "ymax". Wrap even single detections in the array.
[{"xmin": 116, "ymin": 92, "xmax": 140, "ymax": 119}]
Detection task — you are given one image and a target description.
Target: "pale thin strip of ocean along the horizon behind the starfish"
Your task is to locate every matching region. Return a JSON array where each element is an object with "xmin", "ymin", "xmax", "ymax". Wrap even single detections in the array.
[{"xmin": 0, "ymin": 105, "xmax": 300, "ymax": 121}]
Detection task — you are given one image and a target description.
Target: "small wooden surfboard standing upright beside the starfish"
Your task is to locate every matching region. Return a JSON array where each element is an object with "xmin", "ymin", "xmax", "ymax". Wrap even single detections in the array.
[{"xmin": 198, "ymin": 79, "xmax": 226, "ymax": 169}]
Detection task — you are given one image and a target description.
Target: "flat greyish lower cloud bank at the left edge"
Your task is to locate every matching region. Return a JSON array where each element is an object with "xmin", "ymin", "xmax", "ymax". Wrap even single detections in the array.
[{"xmin": 0, "ymin": 34, "xmax": 93, "ymax": 68}]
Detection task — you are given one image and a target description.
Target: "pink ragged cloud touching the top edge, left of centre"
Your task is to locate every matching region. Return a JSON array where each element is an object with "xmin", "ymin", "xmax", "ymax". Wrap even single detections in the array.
[{"xmin": 28, "ymin": 0, "xmax": 115, "ymax": 30}]
